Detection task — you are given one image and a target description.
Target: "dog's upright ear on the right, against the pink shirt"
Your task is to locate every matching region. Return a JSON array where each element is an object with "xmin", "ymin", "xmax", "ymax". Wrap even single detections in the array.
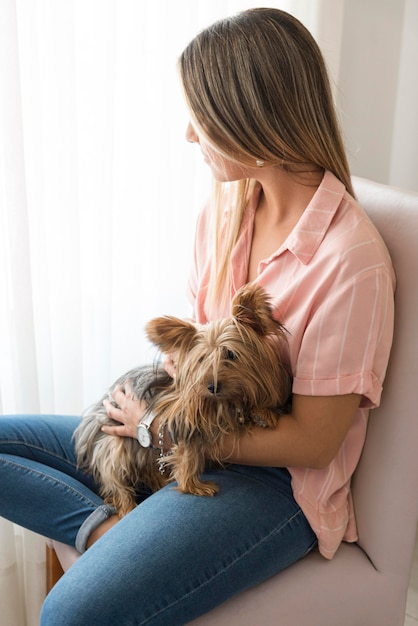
[{"xmin": 232, "ymin": 285, "xmax": 283, "ymax": 335}]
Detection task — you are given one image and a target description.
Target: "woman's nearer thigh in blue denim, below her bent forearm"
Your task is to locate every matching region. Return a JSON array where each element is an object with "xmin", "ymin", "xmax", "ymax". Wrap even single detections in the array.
[{"xmin": 41, "ymin": 466, "xmax": 316, "ymax": 626}]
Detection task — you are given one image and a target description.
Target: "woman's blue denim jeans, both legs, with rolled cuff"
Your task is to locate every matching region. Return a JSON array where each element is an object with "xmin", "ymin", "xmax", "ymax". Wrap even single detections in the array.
[{"xmin": 0, "ymin": 416, "xmax": 316, "ymax": 626}]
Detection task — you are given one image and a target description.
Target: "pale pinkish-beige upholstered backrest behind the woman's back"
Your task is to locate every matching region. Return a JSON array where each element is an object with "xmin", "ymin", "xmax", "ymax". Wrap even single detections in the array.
[{"xmin": 353, "ymin": 177, "xmax": 418, "ymax": 579}]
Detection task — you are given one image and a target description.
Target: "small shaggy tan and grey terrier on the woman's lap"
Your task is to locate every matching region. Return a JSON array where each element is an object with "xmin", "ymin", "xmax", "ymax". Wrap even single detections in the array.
[{"xmin": 75, "ymin": 286, "xmax": 290, "ymax": 516}]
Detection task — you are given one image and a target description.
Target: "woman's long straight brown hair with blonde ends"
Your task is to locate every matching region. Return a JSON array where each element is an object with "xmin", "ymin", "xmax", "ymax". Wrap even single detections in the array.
[{"xmin": 179, "ymin": 8, "xmax": 353, "ymax": 310}]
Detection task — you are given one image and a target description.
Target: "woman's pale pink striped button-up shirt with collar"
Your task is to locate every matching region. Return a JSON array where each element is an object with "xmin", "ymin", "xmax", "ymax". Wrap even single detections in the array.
[{"xmin": 190, "ymin": 172, "xmax": 395, "ymax": 558}]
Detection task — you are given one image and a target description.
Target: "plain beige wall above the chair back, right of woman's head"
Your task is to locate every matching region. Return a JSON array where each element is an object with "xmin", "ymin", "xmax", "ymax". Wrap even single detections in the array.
[{"xmin": 334, "ymin": 0, "xmax": 418, "ymax": 190}]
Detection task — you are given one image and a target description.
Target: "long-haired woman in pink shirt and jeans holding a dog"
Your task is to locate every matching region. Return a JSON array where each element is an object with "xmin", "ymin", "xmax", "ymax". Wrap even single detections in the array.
[{"xmin": 0, "ymin": 9, "xmax": 394, "ymax": 626}]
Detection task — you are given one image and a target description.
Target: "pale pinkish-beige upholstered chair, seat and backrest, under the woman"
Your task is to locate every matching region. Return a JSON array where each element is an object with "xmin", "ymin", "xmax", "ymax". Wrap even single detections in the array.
[{"xmin": 47, "ymin": 178, "xmax": 418, "ymax": 626}]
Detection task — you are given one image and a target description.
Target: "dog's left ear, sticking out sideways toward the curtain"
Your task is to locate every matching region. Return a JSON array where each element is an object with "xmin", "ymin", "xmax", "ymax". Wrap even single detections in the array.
[{"xmin": 145, "ymin": 316, "xmax": 197, "ymax": 354}]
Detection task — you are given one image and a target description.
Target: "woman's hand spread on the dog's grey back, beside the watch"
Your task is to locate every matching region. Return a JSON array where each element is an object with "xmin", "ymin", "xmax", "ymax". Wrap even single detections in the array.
[{"xmin": 102, "ymin": 381, "xmax": 147, "ymax": 439}]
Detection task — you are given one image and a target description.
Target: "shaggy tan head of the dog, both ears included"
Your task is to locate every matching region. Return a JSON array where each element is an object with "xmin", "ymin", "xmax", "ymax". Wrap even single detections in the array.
[{"xmin": 146, "ymin": 286, "xmax": 289, "ymax": 413}]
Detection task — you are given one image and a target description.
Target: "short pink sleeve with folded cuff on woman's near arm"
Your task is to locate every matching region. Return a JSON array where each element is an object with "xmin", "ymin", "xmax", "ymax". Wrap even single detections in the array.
[{"xmin": 293, "ymin": 265, "xmax": 394, "ymax": 408}]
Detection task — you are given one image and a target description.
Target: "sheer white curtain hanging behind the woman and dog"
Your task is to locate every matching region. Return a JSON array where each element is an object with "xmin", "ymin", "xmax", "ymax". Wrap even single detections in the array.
[{"xmin": 0, "ymin": 0, "xmax": 416, "ymax": 626}]
